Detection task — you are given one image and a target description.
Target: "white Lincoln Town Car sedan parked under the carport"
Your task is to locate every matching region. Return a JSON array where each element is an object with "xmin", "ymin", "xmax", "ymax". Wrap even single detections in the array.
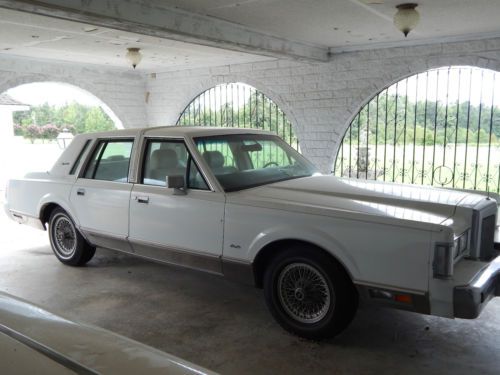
[{"xmin": 6, "ymin": 127, "xmax": 500, "ymax": 339}]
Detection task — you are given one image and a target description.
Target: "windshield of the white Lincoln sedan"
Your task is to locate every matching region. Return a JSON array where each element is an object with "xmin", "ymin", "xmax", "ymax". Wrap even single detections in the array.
[{"xmin": 194, "ymin": 134, "xmax": 316, "ymax": 191}]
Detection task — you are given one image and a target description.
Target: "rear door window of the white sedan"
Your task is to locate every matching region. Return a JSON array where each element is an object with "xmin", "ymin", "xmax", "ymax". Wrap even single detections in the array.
[{"xmin": 83, "ymin": 139, "xmax": 134, "ymax": 182}]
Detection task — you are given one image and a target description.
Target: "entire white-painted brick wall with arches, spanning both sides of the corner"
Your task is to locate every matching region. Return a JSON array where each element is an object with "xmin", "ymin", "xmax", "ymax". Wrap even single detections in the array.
[{"xmin": 0, "ymin": 38, "xmax": 500, "ymax": 172}]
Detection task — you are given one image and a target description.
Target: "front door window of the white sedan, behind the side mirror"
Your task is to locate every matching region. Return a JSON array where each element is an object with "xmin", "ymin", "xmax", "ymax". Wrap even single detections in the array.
[{"xmin": 142, "ymin": 140, "xmax": 208, "ymax": 190}]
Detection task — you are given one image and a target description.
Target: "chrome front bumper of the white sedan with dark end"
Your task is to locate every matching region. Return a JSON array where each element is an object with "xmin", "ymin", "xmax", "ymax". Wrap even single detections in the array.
[{"xmin": 453, "ymin": 256, "xmax": 500, "ymax": 319}]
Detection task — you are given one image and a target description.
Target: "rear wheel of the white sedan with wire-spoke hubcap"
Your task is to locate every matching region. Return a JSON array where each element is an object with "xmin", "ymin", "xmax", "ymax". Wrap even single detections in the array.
[{"xmin": 49, "ymin": 208, "xmax": 95, "ymax": 266}]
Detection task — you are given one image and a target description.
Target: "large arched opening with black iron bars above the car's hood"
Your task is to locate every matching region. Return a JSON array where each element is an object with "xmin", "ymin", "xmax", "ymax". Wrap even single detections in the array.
[{"xmin": 334, "ymin": 66, "xmax": 500, "ymax": 193}]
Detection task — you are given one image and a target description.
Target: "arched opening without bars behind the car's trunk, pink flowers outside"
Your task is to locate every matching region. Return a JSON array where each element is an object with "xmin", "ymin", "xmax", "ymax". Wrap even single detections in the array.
[{"xmin": 0, "ymin": 80, "xmax": 123, "ymax": 190}]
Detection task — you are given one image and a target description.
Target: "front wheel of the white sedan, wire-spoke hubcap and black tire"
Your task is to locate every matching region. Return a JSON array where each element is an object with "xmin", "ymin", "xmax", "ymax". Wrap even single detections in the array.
[{"xmin": 264, "ymin": 245, "xmax": 358, "ymax": 340}]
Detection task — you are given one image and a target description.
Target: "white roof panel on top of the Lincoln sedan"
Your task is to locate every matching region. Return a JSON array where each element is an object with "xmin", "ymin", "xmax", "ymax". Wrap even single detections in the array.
[{"xmin": 87, "ymin": 126, "xmax": 274, "ymax": 138}]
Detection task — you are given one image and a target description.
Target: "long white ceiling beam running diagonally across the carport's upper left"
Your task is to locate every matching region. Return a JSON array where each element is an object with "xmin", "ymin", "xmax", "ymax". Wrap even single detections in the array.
[{"xmin": 0, "ymin": 0, "xmax": 329, "ymax": 61}]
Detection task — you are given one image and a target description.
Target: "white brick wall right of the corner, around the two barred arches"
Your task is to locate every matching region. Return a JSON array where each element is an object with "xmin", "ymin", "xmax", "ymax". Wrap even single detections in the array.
[{"xmin": 146, "ymin": 39, "xmax": 500, "ymax": 172}]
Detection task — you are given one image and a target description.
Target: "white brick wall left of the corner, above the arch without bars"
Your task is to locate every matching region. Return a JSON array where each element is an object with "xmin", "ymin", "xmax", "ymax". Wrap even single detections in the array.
[{"xmin": 0, "ymin": 55, "xmax": 148, "ymax": 128}]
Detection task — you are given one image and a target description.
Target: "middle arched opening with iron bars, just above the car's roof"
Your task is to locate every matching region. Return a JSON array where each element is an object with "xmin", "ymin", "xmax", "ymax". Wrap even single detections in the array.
[{"xmin": 177, "ymin": 82, "xmax": 299, "ymax": 150}]
